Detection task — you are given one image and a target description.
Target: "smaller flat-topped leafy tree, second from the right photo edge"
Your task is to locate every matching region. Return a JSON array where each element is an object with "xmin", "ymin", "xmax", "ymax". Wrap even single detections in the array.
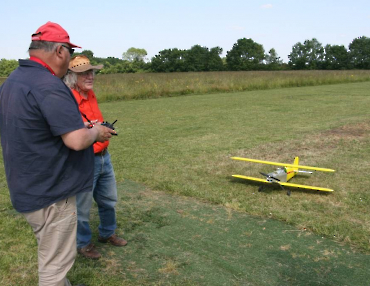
[{"xmin": 322, "ymin": 45, "xmax": 348, "ymax": 70}]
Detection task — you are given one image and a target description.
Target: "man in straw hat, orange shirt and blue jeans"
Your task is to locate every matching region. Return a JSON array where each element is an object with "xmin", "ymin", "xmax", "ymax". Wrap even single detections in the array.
[{"xmin": 64, "ymin": 55, "xmax": 127, "ymax": 259}]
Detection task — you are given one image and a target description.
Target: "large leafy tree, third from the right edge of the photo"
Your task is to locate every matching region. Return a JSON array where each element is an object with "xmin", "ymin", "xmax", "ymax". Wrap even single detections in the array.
[{"xmin": 288, "ymin": 38, "xmax": 324, "ymax": 70}]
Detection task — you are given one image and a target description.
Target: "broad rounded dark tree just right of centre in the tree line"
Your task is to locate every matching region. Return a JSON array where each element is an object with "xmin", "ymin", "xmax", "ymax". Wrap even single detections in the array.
[{"xmin": 226, "ymin": 38, "xmax": 265, "ymax": 71}]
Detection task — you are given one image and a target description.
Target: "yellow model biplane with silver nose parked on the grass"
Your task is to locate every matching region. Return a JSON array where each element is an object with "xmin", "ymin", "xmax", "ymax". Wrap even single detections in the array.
[{"xmin": 231, "ymin": 157, "xmax": 335, "ymax": 196}]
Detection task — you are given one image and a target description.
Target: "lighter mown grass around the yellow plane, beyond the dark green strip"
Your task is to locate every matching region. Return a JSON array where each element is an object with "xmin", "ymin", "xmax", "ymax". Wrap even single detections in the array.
[{"xmin": 103, "ymin": 83, "xmax": 370, "ymax": 251}]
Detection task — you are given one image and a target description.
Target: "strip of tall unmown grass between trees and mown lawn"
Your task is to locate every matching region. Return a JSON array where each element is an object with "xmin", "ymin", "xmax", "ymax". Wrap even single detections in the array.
[{"xmin": 95, "ymin": 70, "xmax": 370, "ymax": 102}]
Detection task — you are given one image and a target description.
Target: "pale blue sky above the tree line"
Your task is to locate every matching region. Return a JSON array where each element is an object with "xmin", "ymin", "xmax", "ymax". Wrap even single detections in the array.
[{"xmin": 0, "ymin": 0, "xmax": 370, "ymax": 62}]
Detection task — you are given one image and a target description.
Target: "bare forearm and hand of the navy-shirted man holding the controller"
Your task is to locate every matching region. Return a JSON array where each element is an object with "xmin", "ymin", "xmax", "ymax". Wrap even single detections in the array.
[{"xmin": 62, "ymin": 124, "xmax": 114, "ymax": 151}]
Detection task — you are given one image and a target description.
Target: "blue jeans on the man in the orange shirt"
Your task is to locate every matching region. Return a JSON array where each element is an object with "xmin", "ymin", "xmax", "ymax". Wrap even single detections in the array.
[{"xmin": 76, "ymin": 152, "xmax": 117, "ymax": 248}]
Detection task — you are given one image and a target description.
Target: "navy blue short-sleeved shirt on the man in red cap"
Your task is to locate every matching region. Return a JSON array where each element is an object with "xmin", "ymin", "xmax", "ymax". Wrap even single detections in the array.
[{"xmin": 0, "ymin": 60, "xmax": 94, "ymax": 212}]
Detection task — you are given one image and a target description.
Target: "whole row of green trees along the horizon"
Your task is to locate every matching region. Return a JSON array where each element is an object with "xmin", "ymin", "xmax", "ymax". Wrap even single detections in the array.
[{"xmin": 0, "ymin": 36, "xmax": 370, "ymax": 77}]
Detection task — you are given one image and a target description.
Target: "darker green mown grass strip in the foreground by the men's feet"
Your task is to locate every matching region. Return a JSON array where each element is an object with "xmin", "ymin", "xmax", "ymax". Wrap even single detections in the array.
[{"xmin": 0, "ymin": 180, "xmax": 370, "ymax": 286}]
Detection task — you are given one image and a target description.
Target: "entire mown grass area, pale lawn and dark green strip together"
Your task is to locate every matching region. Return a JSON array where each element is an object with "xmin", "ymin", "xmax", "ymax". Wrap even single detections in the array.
[{"xmin": 0, "ymin": 75, "xmax": 370, "ymax": 285}]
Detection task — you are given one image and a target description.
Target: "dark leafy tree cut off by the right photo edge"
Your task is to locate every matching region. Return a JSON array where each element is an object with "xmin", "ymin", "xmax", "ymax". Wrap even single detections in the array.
[{"xmin": 349, "ymin": 36, "xmax": 370, "ymax": 69}]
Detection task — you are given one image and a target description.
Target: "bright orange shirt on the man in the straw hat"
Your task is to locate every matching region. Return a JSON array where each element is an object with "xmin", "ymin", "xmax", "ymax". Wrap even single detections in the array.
[{"xmin": 72, "ymin": 89, "xmax": 109, "ymax": 153}]
